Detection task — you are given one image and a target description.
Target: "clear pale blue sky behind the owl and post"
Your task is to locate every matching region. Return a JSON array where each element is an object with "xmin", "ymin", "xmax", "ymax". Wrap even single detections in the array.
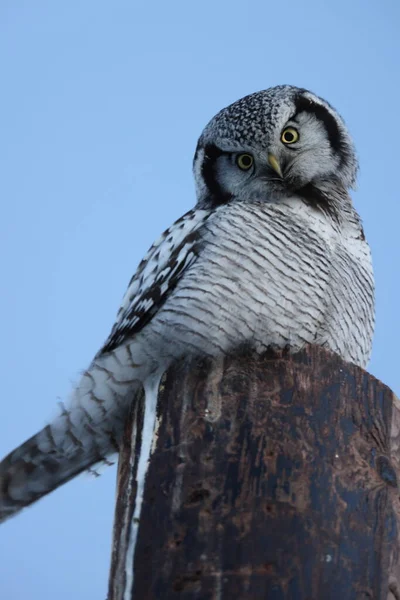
[{"xmin": 0, "ymin": 0, "xmax": 400, "ymax": 600}]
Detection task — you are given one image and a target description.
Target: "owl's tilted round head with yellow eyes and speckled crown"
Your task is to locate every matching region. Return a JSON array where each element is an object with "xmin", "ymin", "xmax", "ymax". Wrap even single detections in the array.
[{"xmin": 194, "ymin": 85, "xmax": 357, "ymax": 206}]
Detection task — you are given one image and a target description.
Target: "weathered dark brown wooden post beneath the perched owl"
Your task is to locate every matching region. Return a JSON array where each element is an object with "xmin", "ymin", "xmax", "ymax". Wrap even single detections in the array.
[{"xmin": 108, "ymin": 347, "xmax": 400, "ymax": 600}]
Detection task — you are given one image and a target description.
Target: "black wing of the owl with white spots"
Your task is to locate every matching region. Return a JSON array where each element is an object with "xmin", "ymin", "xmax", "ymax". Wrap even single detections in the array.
[{"xmin": 98, "ymin": 209, "xmax": 211, "ymax": 356}]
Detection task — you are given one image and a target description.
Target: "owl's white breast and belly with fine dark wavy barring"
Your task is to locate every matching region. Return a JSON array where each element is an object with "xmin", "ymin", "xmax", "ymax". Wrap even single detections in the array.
[{"xmin": 138, "ymin": 202, "xmax": 373, "ymax": 366}]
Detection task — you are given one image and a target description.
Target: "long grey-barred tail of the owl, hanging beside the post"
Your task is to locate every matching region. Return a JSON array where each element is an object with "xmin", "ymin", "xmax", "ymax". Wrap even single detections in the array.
[{"xmin": 0, "ymin": 353, "xmax": 140, "ymax": 523}]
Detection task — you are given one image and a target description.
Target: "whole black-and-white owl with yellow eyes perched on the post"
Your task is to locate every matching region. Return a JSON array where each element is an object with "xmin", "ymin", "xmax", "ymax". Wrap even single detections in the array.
[{"xmin": 0, "ymin": 85, "xmax": 374, "ymax": 520}]
